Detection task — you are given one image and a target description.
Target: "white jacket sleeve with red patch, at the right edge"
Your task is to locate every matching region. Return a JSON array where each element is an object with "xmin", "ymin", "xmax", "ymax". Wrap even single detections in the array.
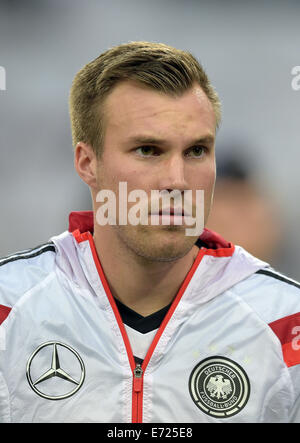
[{"xmin": 236, "ymin": 267, "xmax": 300, "ymax": 423}]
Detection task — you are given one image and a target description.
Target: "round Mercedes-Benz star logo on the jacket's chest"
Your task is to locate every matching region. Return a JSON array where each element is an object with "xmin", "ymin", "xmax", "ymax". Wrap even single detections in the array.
[{"xmin": 26, "ymin": 341, "xmax": 85, "ymax": 400}]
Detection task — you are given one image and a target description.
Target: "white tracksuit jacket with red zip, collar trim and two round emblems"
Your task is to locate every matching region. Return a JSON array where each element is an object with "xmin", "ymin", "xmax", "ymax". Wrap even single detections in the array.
[{"xmin": 0, "ymin": 213, "xmax": 300, "ymax": 423}]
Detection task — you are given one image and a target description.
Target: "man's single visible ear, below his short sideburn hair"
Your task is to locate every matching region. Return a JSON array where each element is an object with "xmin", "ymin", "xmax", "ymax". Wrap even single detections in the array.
[{"xmin": 74, "ymin": 142, "xmax": 97, "ymax": 189}]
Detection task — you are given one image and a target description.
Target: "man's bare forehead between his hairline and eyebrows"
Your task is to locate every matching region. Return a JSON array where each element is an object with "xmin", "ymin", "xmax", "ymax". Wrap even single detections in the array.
[{"xmin": 104, "ymin": 81, "xmax": 216, "ymax": 140}]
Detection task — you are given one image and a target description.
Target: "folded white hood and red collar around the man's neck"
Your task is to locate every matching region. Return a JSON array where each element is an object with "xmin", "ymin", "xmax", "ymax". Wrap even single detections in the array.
[{"xmin": 51, "ymin": 211, "xmax": 269, "ymax": 306}]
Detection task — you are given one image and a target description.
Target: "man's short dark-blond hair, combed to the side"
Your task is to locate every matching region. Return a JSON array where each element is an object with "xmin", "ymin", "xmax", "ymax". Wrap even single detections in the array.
[{"xmin": 69, "ymin": 41, "xmax": 221, "ymax": 156}]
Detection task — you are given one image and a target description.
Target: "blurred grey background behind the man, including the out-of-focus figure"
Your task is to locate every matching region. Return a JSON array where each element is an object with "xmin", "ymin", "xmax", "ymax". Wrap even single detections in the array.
[{"xmin": 0, "ymin": 0, "xmax": 300, "ymax": 279}]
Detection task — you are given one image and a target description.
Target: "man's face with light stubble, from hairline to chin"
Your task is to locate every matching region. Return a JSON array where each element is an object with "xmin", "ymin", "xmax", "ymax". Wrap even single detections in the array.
[{"xmin": 94, "ymin": 81, "xmax": 216, "ymax": 261}]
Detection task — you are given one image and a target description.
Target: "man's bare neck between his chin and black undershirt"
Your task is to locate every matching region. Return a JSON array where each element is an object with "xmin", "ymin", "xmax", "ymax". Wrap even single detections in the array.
[{"xmin": 94, "ymin": 226, "xmax": 199, "ymax": 316}]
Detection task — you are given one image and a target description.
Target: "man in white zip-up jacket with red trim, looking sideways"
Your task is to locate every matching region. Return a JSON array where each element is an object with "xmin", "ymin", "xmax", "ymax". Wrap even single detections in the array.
[{"xmin": 0, "ymin": 42, "xmax": 300, "ymax": 423}]
